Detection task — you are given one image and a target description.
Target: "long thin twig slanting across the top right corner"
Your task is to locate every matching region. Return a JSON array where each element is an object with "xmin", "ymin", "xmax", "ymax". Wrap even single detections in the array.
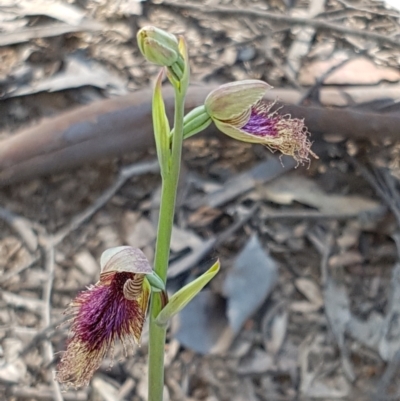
[{"xmin": 161, "ymin": 1, "xmax": 400, "ymax": 47}]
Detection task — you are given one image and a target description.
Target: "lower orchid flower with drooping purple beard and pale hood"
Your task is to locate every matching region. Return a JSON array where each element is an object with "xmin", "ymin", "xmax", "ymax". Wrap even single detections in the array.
[{"xmin": 56, "ymin": 246, "xmax": 163, "ymax": 387}]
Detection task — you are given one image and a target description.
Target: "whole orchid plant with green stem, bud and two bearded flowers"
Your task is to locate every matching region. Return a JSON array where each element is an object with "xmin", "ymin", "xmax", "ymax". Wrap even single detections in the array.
[{"xmin": 56, "ymin": 27, "xmax": 317, "ymax": 401}]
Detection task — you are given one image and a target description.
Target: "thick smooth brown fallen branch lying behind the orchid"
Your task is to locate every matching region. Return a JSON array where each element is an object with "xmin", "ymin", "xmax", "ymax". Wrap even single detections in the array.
[{"xmin": 0, "ymin": 85, "xmax": 400, "ymax": 186}]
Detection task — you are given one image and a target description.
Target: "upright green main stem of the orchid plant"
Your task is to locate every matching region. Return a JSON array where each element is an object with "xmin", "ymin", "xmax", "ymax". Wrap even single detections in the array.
[{"xmin": 148, "ymin": 90, "xmax": 184, "ymax": 401}]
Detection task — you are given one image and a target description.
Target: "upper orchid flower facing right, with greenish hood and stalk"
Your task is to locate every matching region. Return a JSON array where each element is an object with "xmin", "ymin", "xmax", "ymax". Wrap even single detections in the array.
[{"xmin": 184, "ymin": 80, "xmax": 318, "ymax": 164}]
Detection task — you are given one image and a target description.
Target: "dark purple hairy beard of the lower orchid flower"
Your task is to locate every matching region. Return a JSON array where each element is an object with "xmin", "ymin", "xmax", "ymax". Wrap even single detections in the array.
[{"xmin": 56, "ymin": 272, "xmax": 148, "ymax": 387}]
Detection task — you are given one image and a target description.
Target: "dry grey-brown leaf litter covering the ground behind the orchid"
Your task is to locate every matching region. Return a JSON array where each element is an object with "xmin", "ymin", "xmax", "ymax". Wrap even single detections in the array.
[{"xmin": 0, "ymin": 0, "xmax": 400, "ymax": 401}]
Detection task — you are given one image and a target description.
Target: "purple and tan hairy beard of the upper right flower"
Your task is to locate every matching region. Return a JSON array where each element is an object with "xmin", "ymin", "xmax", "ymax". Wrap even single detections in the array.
[{"xmin": 240, "ymin": 101, "xmax": 318, "ymax": 164}]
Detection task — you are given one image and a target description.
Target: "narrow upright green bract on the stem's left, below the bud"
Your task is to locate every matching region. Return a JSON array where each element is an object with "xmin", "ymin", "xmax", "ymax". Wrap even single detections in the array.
[{"xmin": 152, "ymin": 69, "xmax": 171, "ymax": 177}]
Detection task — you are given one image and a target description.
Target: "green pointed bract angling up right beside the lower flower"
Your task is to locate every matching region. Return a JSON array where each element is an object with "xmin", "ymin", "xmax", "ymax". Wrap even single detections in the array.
[{"xmin": 155, "ymin": 260, "xmax": 220, "ymax": 326}]
